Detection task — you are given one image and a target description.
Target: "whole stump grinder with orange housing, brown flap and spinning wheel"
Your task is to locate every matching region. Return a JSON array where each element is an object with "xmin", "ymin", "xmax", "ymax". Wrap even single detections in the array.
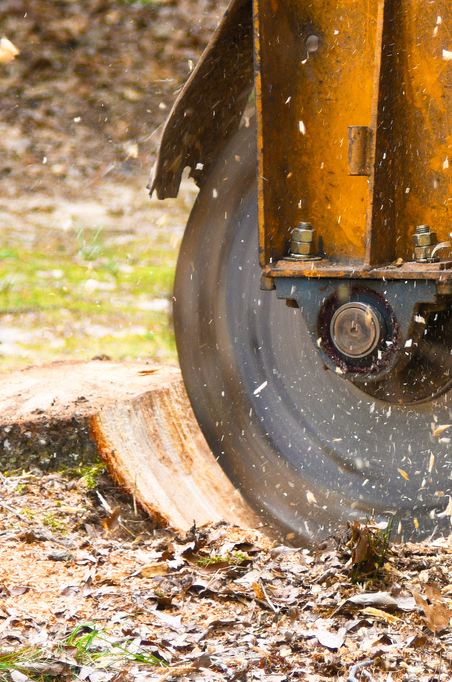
[{"xmin": 151, "ymin": 0, "xmax": 452, "ymax": 543}]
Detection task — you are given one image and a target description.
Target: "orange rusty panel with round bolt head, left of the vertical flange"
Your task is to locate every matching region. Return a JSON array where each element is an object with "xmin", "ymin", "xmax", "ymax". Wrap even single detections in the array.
[{"xmin": 257, "ymin": 0, "xmax": 378, "ymax": 263}]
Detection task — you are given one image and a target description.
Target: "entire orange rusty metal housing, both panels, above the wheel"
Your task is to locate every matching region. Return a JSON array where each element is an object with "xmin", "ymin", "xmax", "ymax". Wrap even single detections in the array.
[{"xmin": 255, "ymin": 0, "xmax": 452, "ymax": 277}]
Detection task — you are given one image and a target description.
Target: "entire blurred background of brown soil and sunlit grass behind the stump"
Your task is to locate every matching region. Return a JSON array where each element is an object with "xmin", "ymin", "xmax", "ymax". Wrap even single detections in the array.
[{"xmin": 0, "ymin": 0, "xmax": 226, "ymax": 369}]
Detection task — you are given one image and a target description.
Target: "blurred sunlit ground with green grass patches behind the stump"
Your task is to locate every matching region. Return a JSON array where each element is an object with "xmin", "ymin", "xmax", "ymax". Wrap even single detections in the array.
[{"xmin": 0, "ymin": 175, "xmax": 196, "ymax": 369}]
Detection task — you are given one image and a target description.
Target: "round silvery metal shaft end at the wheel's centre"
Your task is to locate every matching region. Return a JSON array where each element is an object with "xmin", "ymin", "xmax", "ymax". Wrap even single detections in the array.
[{"xmin": 330, "ymin": 302, "xmax": 383, "ymax": 358}]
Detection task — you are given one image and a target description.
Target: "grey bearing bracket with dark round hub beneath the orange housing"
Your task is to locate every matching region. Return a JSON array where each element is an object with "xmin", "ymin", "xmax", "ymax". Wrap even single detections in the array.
[{"xmin": 276, "ymin": 277, "xmax": 452, "ymax": 404}]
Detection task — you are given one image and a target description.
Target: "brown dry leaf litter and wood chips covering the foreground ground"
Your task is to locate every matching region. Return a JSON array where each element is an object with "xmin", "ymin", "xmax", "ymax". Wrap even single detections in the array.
[{"xmin": 0, "ymin": 470, "xmax": 452, "ymax": 682}]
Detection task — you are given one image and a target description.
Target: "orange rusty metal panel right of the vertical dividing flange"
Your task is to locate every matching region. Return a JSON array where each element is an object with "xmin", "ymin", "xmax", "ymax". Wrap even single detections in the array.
[{"xmin": 392, "ymin": 0, "xmax": 452, "ymax": 258}]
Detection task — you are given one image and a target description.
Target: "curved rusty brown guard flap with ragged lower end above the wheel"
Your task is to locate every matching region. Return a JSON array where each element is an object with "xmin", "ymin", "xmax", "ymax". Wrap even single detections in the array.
[{"xmin": 150, "ymin": 0, "xmax": 254, "ymax": 199}]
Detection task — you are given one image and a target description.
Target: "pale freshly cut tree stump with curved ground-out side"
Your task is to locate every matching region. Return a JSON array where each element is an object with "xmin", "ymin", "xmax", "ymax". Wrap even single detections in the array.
[{"xmin": 0, "ymin": 360, "xmax": 260, "ymax": 530}]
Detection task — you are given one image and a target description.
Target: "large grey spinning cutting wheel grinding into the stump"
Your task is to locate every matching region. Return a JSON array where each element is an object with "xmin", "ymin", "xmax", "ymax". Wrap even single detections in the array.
[{"xmin": 174, "ymin": 118, "xmax": 452, "ymax": 543}]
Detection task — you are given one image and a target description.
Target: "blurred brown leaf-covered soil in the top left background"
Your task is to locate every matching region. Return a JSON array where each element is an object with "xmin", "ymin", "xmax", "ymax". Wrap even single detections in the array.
[{"xmin": 0, "ymin": 0, "xmax": 225, "ymax": 199}]
